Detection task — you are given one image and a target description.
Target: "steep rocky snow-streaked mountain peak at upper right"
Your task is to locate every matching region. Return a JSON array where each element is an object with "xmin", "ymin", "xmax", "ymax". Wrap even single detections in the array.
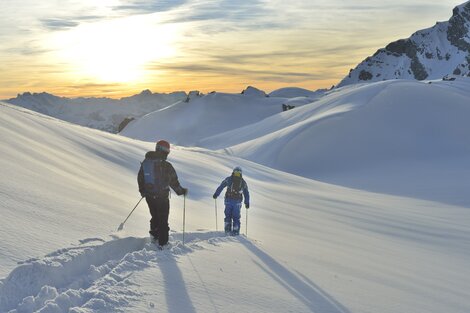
[{"xmin": 338, "ymin": 1, "xmax": 470, "ymax": 87}]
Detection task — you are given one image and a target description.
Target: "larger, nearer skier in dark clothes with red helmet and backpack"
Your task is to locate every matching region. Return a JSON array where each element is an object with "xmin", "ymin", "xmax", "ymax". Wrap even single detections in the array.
[{"xmin": 137, "ymin": 140, "xmax": 188, "ymax": 246}]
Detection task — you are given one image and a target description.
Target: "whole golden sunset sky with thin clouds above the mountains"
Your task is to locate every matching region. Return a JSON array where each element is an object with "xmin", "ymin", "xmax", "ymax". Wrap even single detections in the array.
[{"xmin": 0, "ymin": 0, "xmax": 465, "ymax": 99}]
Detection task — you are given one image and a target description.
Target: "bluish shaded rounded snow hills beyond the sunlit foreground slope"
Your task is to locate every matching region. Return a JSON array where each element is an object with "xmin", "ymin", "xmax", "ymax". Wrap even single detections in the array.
[{"xmin": 121, "ymin": 78, "xmax": 470, "ymax": 205}]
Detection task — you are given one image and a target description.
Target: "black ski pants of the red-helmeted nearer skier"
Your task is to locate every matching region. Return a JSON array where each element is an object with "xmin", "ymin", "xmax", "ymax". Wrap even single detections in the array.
[{"xmin": 145, "ymin": 196, "xmax": 170, "ymax": 246}]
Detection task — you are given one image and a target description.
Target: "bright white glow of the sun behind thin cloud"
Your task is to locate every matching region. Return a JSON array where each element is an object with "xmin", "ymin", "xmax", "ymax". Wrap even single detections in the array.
[{"xmin": 50, "ymin": 17, "xmax": 177, "ymax": 83}]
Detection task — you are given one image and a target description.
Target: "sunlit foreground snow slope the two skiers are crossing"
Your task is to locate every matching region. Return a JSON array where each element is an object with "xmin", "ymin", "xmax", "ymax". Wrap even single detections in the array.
[{"xmin": 0, "ymin": 104, "xmax": 470, "ymax": 313}]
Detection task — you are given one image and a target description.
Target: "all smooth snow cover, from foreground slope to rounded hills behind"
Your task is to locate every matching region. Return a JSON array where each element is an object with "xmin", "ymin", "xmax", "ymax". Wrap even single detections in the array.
[{"xmin": 0, "ymin": 74, "xmax": 470, "ymax": 313}]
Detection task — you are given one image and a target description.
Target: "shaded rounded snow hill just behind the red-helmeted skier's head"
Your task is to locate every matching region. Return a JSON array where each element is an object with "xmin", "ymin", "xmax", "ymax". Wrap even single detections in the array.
[{"xmin": 120, "ymin": 89, "xmax": 288, "ymax": 146}]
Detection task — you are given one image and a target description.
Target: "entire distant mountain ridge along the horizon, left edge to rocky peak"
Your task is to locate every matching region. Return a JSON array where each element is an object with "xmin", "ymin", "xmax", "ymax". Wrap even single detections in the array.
[{"xmin": 3, "ymin": 86, "xmax": 325, "ymax": 133}]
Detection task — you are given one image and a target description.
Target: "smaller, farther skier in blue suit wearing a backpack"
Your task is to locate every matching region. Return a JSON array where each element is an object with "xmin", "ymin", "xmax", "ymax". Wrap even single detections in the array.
[{"xmin": 212, "ymin": 166, "xmax": 250, "ymax": 236}]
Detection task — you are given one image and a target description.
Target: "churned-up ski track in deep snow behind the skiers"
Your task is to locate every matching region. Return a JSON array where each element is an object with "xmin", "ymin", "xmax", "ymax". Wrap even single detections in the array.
[{"xmin": 0, "ymin": 232, "xmax": 238, "ymax": 313}]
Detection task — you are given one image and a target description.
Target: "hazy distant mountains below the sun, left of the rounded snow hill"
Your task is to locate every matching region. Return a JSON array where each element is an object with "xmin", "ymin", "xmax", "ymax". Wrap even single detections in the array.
[{"xmin": 5, "ymin": 90, "xmax": 188, "ymax": 133}]
